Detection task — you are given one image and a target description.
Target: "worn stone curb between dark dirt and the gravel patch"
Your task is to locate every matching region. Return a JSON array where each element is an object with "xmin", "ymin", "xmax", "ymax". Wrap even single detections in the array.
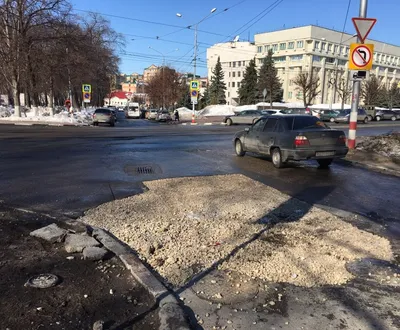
[{"xmin": 92, "ymin": 227, "xmax": 190, "ymax": 330}]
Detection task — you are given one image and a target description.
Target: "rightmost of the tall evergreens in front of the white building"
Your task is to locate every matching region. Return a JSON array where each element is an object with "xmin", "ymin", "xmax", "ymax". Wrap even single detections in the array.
[{"xmin": 258, "ymin": 49, "xmax": 283, "ymax": 108}]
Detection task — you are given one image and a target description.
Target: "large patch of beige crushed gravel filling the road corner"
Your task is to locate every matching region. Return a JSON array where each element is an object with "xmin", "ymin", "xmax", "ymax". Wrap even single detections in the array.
[{"xmin": 81, "ymin": 175, "xmax": 392, "ymax": 287}]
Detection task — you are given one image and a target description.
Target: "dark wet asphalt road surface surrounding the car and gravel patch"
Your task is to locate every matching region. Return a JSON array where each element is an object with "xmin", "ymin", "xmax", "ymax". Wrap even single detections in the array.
[{"xmin": 0, "ymin": 113, "xmax": 400, "ymax": 224}]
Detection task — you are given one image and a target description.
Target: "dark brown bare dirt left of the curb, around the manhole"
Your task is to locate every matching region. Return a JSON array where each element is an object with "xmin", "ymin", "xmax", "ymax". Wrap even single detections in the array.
[{"xmin": 0, "ymin": 206, "xmax": 159, "ymax": 330}]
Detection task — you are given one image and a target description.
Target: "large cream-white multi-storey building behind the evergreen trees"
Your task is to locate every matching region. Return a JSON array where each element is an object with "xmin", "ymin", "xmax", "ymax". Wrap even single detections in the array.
[{"xmin": 207, "ymin": 25, "xmax": 400, "ymax": 104}]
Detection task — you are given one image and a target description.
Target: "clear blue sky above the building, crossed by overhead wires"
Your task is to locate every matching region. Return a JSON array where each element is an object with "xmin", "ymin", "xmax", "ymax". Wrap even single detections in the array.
[{"xmin": 71, "ymin": 0, "xmax": 400, "ymax": 75}]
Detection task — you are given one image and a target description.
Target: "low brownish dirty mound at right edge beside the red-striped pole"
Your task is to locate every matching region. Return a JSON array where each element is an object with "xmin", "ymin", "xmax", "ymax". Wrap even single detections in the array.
[{"xmin": 357, "ymin": 132, "xmax": 400, "ymax": 161}]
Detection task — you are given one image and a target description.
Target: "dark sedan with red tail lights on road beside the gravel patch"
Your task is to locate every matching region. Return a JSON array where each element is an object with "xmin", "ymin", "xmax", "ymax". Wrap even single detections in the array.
[{"xmin": 233, "ymin": 115, "xmax": 348, "ymax": 168}]
